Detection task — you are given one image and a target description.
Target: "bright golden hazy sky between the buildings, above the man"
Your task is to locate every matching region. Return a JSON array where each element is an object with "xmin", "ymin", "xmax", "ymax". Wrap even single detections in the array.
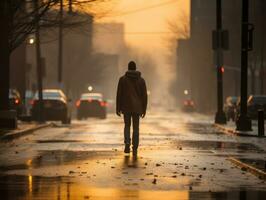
[{"xmin": 96, "ymin": 0, "xmax": 190, "ymax": 106}]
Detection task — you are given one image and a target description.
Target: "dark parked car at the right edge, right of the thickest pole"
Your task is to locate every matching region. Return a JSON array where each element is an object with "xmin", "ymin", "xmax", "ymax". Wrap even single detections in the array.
[{"xmin": 247, "ymin": 95, "xmax": 266, "ymax": 119}]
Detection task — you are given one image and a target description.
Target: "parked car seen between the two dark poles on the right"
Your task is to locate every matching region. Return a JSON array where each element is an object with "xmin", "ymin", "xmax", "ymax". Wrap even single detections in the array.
[{"xmin": 224, "ymin": 96, "xmax": 239, "ymax": 121}]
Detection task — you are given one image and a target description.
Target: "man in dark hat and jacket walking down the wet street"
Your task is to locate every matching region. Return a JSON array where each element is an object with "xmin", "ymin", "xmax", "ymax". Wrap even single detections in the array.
[{"xmin": 116, "ymin": 61, "xmax": 148, "ymax": 155}]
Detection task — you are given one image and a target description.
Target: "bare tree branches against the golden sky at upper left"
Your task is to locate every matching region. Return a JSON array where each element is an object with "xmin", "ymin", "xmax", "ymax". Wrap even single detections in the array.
[{"xmin": 9, "ymin": 0, "xmax": 115, "ymax": 52}]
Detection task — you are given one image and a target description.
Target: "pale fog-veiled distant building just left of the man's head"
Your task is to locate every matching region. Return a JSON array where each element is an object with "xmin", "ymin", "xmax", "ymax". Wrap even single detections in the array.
[{"xmin": 91, "ymin": 23, "xmax": 127, "ymax": 100}]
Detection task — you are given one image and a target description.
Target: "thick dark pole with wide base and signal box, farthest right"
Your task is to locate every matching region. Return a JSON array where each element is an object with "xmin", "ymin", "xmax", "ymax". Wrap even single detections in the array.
[{"xmin": 236, "ymin": 0, "xmax": 253, "ymax": 131}]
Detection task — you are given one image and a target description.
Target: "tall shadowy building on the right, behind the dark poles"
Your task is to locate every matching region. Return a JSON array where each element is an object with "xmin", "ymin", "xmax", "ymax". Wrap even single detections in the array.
[{"xmin": 176, "ymin": 0, "xmax": 266, "ymax": 111}]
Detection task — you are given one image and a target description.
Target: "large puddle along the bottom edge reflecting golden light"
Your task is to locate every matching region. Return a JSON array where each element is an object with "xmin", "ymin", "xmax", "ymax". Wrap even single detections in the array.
[{"xmin": 0, "ymin": 175, "xmax": 266, "ymax": 200}]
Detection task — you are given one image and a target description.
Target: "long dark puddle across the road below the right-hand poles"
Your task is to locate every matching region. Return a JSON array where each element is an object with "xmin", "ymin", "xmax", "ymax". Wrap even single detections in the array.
[{"xmin": 175, "ymin": 140, "xmax": 264, "ymax": 153}]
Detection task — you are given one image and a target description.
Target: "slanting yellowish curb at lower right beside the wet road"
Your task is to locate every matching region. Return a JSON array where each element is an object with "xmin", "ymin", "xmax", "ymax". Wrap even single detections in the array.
[{"xmin": 227, "ymin": 157, "xmax": 266, "ymax": 180}]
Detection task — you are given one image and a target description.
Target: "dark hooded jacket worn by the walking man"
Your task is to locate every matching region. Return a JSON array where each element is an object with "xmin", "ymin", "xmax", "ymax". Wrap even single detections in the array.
[{"xmin": 116, "ymin": 70, "xmax": 148, "ymax": 115}]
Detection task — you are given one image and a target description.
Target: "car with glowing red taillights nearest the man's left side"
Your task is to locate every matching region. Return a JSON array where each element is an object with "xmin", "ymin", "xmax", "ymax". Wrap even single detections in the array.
[{"xmin": 76, "ymin": 93, "xmax": 107, "ymax": 120}]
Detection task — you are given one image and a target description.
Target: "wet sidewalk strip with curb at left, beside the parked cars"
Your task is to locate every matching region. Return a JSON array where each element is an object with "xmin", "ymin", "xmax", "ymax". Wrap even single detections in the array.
[{"xmin": 0, "ymin": 121, "xmax": 52, "ymax": 140}]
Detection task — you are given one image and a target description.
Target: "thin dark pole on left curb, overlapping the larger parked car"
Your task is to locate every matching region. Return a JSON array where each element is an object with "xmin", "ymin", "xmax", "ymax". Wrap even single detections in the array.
[{"xmin": 34, "ymin": 0, "xmax": 44, "ymax": 122}]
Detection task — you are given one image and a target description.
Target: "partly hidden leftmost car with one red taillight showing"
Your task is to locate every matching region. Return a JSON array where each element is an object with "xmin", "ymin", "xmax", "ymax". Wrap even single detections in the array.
[{"xmin": 9, "ymin": 89, "xmax": 23, "ymax": 116}]
